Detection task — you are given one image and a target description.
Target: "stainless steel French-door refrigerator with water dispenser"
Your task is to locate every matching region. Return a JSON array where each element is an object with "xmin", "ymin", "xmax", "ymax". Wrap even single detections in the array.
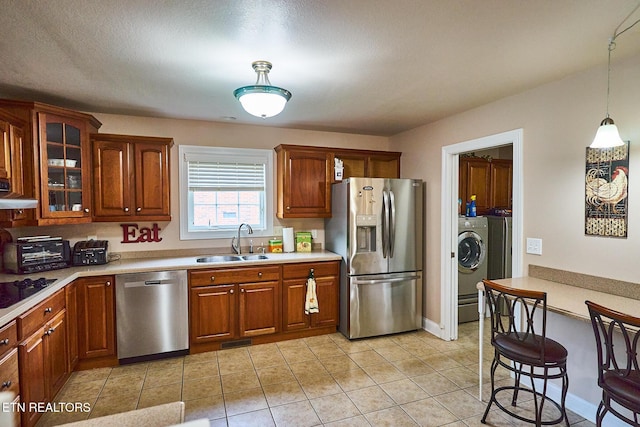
[{"xmin": 325, "ymin": 178, "xmax": 424, "ymax": 339}]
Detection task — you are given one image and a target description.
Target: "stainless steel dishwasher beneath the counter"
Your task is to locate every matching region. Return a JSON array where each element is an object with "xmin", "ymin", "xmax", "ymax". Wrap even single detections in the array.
[{"xmin": 116, "ymin": 270, "xmax": 189, "ymax": 362}]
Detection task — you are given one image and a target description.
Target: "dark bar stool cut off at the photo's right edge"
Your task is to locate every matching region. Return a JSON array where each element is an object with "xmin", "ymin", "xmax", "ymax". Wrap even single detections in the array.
[{"xmin": 585, "ymin": 301, "xmax": 640, "ymax": 427}]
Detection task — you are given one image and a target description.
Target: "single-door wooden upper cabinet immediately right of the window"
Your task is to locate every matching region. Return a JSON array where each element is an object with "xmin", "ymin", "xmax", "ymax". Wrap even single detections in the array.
[{"xmin": 275, "ymin": 145, "xmax": 333, "ymax": 218}]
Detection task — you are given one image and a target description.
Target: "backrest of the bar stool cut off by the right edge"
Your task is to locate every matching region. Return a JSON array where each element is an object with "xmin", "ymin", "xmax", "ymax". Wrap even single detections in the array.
[{"xmin": 585, "ymin": 301, "xmax": 640, "ymax": 386}]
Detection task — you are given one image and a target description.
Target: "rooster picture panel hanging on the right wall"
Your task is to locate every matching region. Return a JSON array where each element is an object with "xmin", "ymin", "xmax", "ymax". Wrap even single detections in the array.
[{"xmin": 584, "ymin": 141, "xmax": 629, "ymax": 238}]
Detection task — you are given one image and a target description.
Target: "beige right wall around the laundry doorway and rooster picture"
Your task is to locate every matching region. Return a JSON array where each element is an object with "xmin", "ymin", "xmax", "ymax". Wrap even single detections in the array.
[{"xmin": 391, "ymin": 56, "xmax": 640, "ymax": 323}]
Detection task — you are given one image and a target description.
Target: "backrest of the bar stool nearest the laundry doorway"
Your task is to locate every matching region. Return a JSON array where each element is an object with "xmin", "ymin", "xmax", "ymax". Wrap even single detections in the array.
[{"xmin": 483, "ymin": 280, "xmax": 547, "ymax": 363}]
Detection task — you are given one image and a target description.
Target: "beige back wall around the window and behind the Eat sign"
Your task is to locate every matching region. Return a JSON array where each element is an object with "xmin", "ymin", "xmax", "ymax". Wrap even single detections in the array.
[{"xmin": 10, "ymin": 113, "xmax": 390, "ymax": 252}]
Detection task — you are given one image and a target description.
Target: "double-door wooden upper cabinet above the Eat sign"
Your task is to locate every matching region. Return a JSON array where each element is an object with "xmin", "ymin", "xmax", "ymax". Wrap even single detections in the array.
[{"xmin": 91, "ymin": 134, "xmax": 173, "ymax": 221}]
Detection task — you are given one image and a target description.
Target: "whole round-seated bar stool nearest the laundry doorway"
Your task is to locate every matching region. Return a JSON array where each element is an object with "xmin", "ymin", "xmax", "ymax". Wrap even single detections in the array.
[{"xmin": 481, "ymin": 280, "xmax": 569, "ymax": 427}]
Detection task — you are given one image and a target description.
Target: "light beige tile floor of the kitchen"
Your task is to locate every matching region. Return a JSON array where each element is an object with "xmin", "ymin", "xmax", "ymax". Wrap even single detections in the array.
[{"xmin": 38, "ymin": 322, "xmax": 593, "ymax": 427}]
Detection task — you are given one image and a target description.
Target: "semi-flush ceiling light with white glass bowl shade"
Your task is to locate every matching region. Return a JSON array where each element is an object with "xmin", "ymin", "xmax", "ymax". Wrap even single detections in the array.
[{"xmin": 233, "ymin": 61, "xmax": 291, "ymax": 119}]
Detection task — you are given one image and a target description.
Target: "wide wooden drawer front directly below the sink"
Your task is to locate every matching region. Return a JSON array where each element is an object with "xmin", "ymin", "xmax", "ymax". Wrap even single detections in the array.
[{"xmin": 189, "ymin": 265, "xmax": 280, "ymax": 287}]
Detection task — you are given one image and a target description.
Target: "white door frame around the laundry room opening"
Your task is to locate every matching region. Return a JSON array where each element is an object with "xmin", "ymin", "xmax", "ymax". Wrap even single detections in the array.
[{"xmin": 440, "ymin": 129, "xmax": 524, "ymax": 341}]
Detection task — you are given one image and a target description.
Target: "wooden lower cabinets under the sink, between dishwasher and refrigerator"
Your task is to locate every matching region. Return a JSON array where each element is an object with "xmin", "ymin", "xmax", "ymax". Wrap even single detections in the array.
[{"xmin": 189, "ymin": 261, "xmax": 340, "ymax": 353}]
